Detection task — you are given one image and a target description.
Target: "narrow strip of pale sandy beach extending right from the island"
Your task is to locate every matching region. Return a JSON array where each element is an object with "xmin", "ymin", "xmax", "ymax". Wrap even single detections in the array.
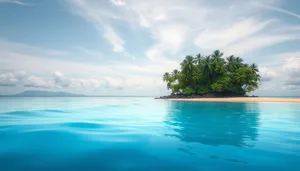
[{"xmin": 168, "ymin": 97, "xmax": 300, "ymax": 103}]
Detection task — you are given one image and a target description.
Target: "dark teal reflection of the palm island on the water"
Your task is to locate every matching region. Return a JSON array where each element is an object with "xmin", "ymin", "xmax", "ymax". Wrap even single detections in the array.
[{"xmin": 165, "ymin": 101, "xmax": 260, "ymax": 147}]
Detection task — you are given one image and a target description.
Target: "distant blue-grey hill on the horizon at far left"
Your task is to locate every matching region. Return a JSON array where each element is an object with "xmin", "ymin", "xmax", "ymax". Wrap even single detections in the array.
[{"xmin": 11, "ymin": 91, "xmax": 85, "ymax": 97}]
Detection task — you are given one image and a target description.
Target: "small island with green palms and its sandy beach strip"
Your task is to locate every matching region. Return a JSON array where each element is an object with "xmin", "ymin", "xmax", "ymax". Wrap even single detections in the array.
[{"xmin": 156, "ymin": 50, "xmax": 300, "ymax": 103}]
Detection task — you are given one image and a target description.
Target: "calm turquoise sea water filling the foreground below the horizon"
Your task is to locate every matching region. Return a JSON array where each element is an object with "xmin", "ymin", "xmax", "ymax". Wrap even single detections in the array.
[{"xmin": 0, "ymin": 97, "xmax": 300, "ymax": 171}]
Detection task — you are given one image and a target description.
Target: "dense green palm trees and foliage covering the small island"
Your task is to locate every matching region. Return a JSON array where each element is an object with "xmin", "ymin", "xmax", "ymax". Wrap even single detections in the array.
[{"xmin": 163, "ymin": 50, "xmax": 260, "ymax": 95}]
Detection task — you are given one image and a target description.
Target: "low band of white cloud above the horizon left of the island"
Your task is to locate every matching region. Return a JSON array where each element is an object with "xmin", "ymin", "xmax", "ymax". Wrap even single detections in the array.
[{"xmin": 0, "ymin": 42, "xmax": 173, "ymax": 95}]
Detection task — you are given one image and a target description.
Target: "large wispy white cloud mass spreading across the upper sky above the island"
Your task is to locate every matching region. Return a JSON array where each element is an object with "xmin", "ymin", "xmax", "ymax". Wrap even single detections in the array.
[{"xmin": 63, "ymin": 0, "xmax": 300, "ymax": 61}]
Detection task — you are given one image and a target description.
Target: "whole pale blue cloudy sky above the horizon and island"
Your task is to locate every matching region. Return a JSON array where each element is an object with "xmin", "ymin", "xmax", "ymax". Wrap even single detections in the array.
[{"xmin": 0, "ymin": 0, "xmax": 300, "ymax": 96}]
